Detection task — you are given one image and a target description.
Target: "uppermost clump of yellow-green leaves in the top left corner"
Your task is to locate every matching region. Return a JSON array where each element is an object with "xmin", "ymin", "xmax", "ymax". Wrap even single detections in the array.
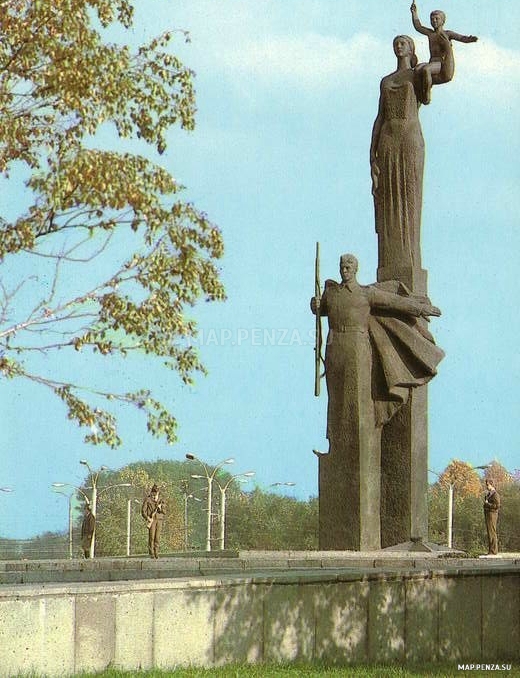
[{"xmin": 0, "ymin": 0, "xmax": 195, "ymax": 171}]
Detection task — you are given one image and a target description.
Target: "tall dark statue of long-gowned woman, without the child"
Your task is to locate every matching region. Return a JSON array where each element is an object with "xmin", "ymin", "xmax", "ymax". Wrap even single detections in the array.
[{"xmin": 370, "ymin": 35, "xmax": 424, "ymax": 268}]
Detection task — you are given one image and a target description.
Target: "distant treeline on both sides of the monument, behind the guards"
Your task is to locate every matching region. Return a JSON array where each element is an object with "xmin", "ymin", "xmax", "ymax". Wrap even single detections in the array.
[{"xmin": 0, "ymin": 460, "xmax": 520, "ymax": 560}]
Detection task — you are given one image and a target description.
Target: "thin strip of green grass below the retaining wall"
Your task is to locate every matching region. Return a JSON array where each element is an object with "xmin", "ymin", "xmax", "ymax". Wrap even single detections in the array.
[{"xmin": 63, "ymin": 662, "xmax": 520, "ymax": 678}]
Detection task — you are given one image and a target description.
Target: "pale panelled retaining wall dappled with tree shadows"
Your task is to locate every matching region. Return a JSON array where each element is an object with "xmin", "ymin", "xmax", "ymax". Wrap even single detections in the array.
[{"xmin": 0, "ymin": 563, "xmax": 520, "ymax": 676}]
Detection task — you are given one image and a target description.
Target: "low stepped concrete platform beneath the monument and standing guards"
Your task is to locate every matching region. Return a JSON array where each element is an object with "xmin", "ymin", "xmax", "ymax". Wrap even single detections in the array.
[{"xmin": 0, "ymin": 550, "xmax": 520, "ymax": 585}]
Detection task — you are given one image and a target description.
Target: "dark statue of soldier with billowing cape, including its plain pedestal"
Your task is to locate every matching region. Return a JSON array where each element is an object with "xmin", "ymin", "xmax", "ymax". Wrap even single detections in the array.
[{"xmin": 311, "ymin": 254, "xmax": 444, "ymax": 550}]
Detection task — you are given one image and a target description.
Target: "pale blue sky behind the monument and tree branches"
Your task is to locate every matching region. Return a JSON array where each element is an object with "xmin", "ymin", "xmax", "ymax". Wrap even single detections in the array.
[{"xmin": 0, "ymin": 0, "xmax": 520, "ymax": 538}]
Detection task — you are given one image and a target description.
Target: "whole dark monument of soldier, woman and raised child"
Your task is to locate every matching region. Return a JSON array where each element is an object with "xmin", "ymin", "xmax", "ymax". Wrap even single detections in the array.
[{"xmin": 311, "ymin": 3, "xmax": 477, "ymax": 550}]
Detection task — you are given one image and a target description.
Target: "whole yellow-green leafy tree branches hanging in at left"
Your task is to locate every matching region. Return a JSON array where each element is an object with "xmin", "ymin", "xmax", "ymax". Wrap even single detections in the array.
[{"xmin": 0, "ymin": 0, "xmax": 225, "ymax": 447}]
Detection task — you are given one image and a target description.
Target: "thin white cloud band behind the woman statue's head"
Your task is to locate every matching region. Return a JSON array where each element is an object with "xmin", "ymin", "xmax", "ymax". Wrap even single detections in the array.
[{"xmin": 204, "ymin": 27, "xmax": 520, "ymax": 100}]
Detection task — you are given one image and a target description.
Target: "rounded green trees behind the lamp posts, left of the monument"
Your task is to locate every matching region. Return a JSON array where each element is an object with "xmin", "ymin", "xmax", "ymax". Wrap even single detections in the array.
[{"xmin": 70, "ymin": 459, "xmax": 318, "ymax": 556}]
